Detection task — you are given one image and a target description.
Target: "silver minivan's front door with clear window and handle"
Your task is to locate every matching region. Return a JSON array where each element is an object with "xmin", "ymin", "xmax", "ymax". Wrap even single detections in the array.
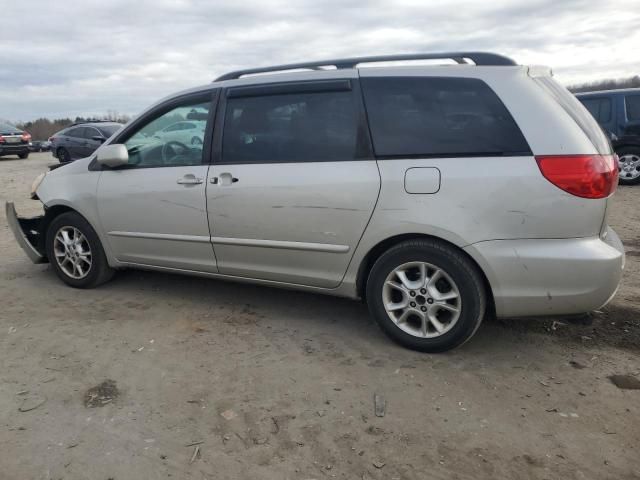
[{"xmin": 97, "ymin": 92, "xmax": 217, "ymax": 272}]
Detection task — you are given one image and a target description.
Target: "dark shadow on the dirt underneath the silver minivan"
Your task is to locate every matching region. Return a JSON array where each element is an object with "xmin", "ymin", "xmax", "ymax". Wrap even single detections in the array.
[{"xmin": 49, "ymin": 269, "xmax": 640, "ymax": 355}]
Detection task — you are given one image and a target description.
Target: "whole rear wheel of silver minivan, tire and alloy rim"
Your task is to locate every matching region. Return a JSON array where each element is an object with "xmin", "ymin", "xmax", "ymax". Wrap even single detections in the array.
[{"xmin": 366, "ymin": 239, "xmax": 486, "ymax": 352}]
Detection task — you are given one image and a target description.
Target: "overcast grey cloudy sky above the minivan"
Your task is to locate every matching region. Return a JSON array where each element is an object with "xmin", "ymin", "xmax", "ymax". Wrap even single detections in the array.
[{"xmin": 0, "ymin": 0, "xmax": 640, "ymax": 121}]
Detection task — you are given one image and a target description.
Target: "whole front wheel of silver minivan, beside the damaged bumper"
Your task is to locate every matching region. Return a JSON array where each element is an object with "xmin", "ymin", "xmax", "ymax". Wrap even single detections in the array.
[{"xmin": 46, "ymin": 212, "xmax": 114, "ymax": 288}]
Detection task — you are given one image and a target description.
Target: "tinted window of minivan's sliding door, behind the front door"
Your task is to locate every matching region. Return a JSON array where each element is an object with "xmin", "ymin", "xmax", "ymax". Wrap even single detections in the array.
[{"xmin": 222, "ymin": 91, "xmax": 358, "ymax": 163}]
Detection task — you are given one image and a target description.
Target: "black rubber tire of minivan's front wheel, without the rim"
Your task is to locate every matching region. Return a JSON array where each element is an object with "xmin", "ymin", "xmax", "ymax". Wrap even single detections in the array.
[{"xmin": 45, "ymin": 212, "xmax": 114, "ymax": 288}]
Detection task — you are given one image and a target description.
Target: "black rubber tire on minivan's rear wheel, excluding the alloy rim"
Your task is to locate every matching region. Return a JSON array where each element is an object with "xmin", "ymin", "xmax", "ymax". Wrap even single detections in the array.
[{"xmin": 366, "ymin": 239, "xmax": 487, "ymax": 353}]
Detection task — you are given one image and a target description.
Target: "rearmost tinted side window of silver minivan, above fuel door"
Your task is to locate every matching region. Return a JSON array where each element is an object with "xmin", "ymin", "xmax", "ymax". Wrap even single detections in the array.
[{"xmin": 361, "ymin": 77, "xmax": 530, "ymax": 157}]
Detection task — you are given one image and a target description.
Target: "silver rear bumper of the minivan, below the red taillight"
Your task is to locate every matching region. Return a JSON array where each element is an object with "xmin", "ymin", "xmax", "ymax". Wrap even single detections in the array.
[{"xmin": 465, "ymin": 228, "xmax": 625, "ymax": 317}]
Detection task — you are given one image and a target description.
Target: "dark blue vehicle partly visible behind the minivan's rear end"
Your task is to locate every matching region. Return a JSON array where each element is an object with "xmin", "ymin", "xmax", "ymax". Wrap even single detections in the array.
[{"xmin": 576, "ymin": 88, "xmax": 640, "ymax": 185}]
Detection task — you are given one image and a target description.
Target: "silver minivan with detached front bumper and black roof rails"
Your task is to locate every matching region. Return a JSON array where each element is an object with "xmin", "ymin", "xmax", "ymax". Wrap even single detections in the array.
[{"xmin": 7, "ymin": 52, "xmax": 625, "ymax": 352}]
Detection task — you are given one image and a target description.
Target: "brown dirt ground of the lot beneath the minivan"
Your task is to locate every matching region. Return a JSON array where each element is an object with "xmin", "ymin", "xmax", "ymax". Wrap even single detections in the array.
[{"xmin": 0, "ymin": 154, "xmax": 640, "ymax": 480}]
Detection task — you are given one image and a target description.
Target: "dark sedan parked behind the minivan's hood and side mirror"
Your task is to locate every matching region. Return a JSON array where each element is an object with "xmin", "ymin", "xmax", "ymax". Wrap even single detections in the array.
[{"xmin": 49, "ymin": 122, "xmax": 122, "ymax": 163}]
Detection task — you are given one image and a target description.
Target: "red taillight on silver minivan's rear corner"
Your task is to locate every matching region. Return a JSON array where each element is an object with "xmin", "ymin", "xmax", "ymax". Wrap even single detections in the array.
[{"xmin": 536, "ymin": 155, "xmax": 618, "ymax": 198}]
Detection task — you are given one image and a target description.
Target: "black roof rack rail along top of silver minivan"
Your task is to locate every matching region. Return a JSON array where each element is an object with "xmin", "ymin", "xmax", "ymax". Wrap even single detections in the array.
[{"xmin": 214, "ymin": 52, "xmax": 517, "ymax": 82}]
